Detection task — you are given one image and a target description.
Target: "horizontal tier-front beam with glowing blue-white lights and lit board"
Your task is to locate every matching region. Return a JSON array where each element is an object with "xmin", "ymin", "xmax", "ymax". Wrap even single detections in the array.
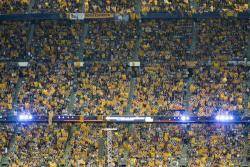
[{"xmin": 0, "ymin": 114, "xmax": 250, "ymax": 124}]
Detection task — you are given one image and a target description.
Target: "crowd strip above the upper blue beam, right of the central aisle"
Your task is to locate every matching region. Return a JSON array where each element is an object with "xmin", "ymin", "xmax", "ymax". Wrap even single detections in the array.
[{"xmin": 141, "ymin": 0, "xmax": 248, "ymax": 15}]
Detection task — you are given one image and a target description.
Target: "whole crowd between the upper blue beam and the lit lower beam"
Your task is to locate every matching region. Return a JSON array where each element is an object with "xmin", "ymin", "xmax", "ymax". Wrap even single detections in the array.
[{"xmin": 0, "ymin": 20, "xmax": 249, "ymax": 116}]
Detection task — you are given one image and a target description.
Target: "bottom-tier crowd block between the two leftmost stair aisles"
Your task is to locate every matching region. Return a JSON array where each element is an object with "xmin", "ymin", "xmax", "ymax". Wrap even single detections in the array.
[{"xmin": 10, "ymin": 124, "xmax": 69, "ymax": 167}]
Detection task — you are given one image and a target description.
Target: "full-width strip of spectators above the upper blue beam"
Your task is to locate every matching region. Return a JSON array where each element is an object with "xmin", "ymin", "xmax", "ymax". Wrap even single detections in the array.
[{"xmin": 0, "ymin": 0, "xmax": 248, "ymax": 14}]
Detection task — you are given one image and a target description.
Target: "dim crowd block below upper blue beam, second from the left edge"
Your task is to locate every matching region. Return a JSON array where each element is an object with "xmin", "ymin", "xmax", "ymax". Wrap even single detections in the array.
[{"xmin": 27, "ymin": 21, "xmax": 81, "ymax": 63}]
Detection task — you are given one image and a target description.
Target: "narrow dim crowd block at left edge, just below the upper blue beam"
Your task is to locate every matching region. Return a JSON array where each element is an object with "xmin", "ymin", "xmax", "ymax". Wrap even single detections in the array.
[{"xmin": 0, "ymin": 21, "xmax": 28, "ymax": 60}]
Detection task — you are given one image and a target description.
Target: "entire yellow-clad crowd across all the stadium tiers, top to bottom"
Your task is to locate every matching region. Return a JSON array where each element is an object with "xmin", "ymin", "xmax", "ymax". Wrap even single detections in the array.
[{"xmin": 0, "ymin": 0, "xmax": 250, "ymax": 167}]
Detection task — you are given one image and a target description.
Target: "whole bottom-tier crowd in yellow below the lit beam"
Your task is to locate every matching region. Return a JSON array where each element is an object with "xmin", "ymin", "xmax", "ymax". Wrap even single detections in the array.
[{"xmin": 1, "ymin": 124, "xmax": 249, "ymax": 167}]
